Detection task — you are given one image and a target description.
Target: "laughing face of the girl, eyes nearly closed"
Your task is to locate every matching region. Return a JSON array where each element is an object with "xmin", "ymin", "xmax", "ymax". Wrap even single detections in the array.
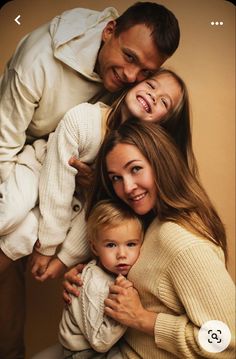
[{"xmin": 122, "ymin": 73, "xmax": 182, "ymax": 122}]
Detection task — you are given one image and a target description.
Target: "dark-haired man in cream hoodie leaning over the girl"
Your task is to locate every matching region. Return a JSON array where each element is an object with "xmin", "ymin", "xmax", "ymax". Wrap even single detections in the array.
[{"xmin": 0, "ymin": 2, "xmax": 180, "ymax": 359}]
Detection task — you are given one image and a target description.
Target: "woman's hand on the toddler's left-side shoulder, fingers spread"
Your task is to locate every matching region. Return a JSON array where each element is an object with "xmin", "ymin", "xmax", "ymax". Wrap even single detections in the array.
[{"xmin": 63, "ymin": 264, "xmax": 85, "ymax": 304}]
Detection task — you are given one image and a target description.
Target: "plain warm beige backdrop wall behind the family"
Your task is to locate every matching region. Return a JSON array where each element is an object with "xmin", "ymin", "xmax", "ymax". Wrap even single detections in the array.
[{"xmin": 0, "ymin": 0, "xmax": 235, "ymax": 357}]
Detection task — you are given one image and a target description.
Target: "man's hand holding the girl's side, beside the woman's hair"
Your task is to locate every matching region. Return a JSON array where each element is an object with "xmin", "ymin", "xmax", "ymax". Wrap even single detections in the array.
[{"xmin": 69, "ymin": 157, "xmax": 93, "ymax": 191}]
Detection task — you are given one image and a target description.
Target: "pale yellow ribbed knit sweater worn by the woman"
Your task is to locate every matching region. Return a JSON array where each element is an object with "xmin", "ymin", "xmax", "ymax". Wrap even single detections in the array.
[{"xmin": 121, "ymin": 220, "xmax": 235, "ymax": 359}]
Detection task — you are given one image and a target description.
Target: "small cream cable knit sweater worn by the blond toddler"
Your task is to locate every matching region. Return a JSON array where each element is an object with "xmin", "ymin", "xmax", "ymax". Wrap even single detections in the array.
[{"xmin": 59, "ymin": 260, "xmax": 126, "ymax": 352}]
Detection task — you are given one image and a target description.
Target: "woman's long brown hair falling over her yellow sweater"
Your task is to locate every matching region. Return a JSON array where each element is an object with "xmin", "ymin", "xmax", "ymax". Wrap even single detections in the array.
[{"xmin": 87, "ymin": 119, "xmax": 227, "ymax": 259}]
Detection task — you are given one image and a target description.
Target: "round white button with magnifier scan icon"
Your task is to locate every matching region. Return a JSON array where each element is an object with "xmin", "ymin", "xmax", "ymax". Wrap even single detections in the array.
[{"xmin": 198, "ymin": 320, "xmax": 231, "ymax": 353}]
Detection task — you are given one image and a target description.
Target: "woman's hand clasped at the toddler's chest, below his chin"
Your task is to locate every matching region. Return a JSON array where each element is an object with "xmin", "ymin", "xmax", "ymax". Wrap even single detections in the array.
[{"xmin": 105, "ymin": 277, "xmax": 157, "ymax": 336}]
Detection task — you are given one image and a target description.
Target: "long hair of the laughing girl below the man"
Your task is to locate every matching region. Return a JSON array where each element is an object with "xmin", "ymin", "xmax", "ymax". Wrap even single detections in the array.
[{"xmin": 107, "ymin": 68, "xmax": 198, "ymax": 175}]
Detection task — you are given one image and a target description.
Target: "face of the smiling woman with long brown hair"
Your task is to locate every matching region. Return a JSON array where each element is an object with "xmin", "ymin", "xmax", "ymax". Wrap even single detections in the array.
[{"xmin": 106, "ymin": 143, "xmax": 157, "ymax": 215}]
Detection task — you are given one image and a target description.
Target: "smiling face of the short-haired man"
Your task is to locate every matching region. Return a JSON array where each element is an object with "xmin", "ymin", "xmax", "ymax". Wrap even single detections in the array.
[{"xmin": 97, "ymin": 21, "xmax": 167, "ymax": 92}]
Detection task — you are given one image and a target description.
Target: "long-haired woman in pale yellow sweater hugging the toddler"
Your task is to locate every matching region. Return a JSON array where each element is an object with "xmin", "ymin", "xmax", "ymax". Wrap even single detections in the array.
[{"xmin": 79, "ymin": 121, "xmax": 235, "ymax": 359}]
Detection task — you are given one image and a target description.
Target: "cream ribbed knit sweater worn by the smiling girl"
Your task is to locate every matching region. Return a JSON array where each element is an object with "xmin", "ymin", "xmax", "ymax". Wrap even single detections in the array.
[{"xmin": 39, "ymin": 103, "xmax": 109, "ymax": 266}]
